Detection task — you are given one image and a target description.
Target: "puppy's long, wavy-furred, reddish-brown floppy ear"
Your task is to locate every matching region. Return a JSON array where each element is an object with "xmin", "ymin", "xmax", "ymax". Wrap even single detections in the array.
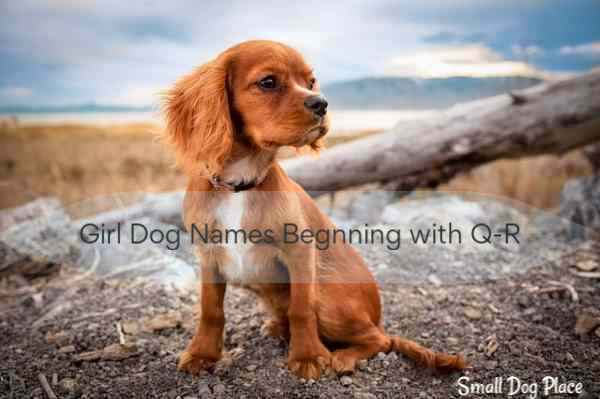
[{"xmin": 164, "ymin": 55, "xmax": 234, "ymax": 174}]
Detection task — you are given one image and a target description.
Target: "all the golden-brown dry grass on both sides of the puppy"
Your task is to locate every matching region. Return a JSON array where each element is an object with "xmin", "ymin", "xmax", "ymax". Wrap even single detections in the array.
[{"xmin": 0, "ymin": 124, "xmax": 592, "ymax": 208}]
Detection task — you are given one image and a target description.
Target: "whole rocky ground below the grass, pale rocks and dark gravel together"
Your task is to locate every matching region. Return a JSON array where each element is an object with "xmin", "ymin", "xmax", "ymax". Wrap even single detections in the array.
[{"xmin": 0, "ymin": 178, "xmax": 600, "ymax": 399}]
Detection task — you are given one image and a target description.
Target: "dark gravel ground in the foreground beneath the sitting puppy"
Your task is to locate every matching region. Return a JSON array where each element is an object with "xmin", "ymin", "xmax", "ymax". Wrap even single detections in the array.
[{"xmin": 0, "ymin": 247, "xmax": 600, "ymax": 398}]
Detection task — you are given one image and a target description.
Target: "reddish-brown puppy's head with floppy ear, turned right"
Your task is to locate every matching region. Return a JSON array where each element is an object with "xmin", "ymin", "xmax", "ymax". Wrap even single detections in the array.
[{"xmin": 165, "ymin": 41, "xmax": 329, "ymax": 173}]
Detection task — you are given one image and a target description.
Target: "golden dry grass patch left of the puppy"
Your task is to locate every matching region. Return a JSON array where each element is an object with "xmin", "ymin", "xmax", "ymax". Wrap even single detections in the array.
[{"xmin": 0, "ymin": 124, "xmax": 185, "ymax": 208}]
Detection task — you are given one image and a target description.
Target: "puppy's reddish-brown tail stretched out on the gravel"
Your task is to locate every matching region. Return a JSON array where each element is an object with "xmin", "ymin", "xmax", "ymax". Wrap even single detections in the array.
[{"xmin": 389, "ymin": 336, "xmax": 467, "ymax": 372}]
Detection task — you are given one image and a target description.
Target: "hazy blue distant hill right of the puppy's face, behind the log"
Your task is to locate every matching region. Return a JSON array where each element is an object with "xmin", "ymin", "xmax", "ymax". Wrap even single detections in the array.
[{"xmin": 322, "ymin": 77, "xmax": 542, "ymax": 109}]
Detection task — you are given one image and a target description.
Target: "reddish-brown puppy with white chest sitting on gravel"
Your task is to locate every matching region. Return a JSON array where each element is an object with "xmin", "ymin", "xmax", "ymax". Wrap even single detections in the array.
[{"xmin": 164, "ymin": 40, "xmax": 466, "ymax": 379}]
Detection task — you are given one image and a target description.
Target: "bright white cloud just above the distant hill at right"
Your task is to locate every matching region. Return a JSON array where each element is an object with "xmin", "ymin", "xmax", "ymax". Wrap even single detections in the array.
[{"xmin": 386, "ymin": 44, "xmax": 544, "ymax": 78}]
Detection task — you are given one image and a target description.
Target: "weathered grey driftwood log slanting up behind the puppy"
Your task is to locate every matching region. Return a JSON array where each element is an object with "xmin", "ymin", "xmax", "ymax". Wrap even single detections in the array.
[{"xmin": 283, "ymin": 71, "xmax": 600, "ymax": 192}]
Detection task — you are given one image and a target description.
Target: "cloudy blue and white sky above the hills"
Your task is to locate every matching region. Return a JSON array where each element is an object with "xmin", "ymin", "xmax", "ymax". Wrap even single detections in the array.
[{"xmin": 0, "ymin": 0, "xmax": 600, "ymax": 106}]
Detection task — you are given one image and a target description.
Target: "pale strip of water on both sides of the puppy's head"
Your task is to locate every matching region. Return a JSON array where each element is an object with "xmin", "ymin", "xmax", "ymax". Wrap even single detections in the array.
[{"xmin": 9, "ymin": 110, "xmax": 436, "ymax": 132}]
